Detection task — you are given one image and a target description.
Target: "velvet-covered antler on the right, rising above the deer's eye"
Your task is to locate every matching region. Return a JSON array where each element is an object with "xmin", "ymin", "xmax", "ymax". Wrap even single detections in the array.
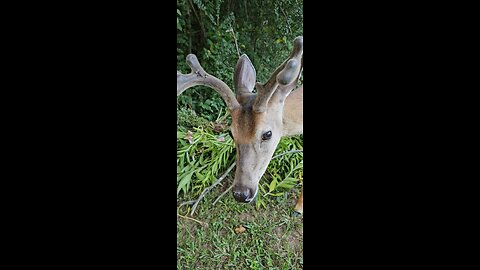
[{"xmin": 253, "ymin": 36, "xmax": 303, "ymax": 112}]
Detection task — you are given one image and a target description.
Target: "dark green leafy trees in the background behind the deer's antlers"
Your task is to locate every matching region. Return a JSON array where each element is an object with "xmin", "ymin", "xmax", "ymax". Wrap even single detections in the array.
[{"xmin": 177, "ymin": 0, "xmax": 303, "ymax": 121}]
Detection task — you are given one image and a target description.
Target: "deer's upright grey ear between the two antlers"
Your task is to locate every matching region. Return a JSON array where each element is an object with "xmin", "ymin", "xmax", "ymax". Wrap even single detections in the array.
[{"xmin": 233, "ymin": 54, "xmax": 257, "ymax": 94}]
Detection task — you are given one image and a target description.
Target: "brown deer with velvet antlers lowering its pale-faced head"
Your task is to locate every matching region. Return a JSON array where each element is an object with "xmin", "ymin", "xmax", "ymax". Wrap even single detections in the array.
[{"xmin": 177, "ymin": 36, "xmax": 303, "ymax": 214}]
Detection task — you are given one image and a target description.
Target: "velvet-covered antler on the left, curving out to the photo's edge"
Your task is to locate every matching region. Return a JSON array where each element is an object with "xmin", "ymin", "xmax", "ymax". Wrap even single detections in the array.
[{"xmin": 177, "ymin": 54, "xmax": 240, "ymax": 110}]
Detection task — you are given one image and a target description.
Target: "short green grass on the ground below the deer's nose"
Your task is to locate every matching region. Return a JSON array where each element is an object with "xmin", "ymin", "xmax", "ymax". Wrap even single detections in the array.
[{"xmin": 177, "ymin": 179, "xmax": 303, "ymax": 269}]
